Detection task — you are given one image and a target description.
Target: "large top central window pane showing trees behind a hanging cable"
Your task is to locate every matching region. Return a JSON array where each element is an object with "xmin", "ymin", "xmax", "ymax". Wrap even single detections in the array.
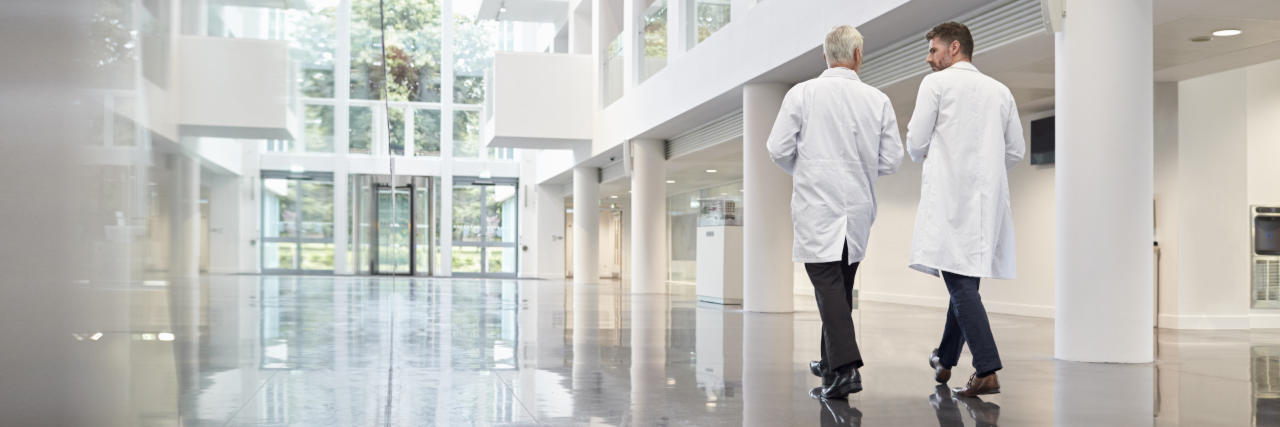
[{"xmin": 351, "ymin": 0, "xmax": 442, "ymax": 102}]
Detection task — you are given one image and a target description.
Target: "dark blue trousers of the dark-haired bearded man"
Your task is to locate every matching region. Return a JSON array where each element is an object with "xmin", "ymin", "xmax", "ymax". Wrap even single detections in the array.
[{"xmin": 938, "ymin": 271, "xmax": 1004, "ymax": 373}]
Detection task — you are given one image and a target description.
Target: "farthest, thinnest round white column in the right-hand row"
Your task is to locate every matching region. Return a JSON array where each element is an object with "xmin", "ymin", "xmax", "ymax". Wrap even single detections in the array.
[{"xmin": 573, "ymin": 166, "xmax": 600, "ymax": 283}]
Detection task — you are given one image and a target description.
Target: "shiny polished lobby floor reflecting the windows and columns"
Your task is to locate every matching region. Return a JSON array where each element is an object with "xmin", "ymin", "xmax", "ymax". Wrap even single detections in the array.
[{"xmin": 107, "ymin": 276, "xmax": 1280, "ymax": 426}]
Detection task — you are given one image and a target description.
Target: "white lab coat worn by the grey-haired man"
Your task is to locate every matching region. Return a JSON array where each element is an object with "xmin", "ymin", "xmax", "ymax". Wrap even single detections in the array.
[{"xmin": 768, "ymin": 68, "xmax": 902, "ymax": 263}]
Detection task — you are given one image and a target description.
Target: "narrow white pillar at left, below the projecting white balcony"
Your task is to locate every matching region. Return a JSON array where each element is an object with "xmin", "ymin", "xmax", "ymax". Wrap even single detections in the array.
[{"xmin": 169, "ymin": 155, "xmax": 201, "ymax": 277}]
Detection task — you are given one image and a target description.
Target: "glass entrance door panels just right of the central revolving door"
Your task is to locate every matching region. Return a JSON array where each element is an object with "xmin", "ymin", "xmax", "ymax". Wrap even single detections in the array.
[{"xmin": 453, "ymin": 178, "xmax": 518, "ymax": 277}]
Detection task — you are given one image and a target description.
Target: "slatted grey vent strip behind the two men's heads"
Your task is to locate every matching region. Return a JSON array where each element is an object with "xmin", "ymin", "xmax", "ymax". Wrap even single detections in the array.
[{"xmin": 860, "ymin": 0, "xmax": 1048, "ymax": 88}]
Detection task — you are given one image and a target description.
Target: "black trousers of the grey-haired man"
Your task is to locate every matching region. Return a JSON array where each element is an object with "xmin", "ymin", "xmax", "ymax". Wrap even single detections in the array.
[{"xmin": 804, "ymin": 245, "xmax": 863, "ymax": 369}]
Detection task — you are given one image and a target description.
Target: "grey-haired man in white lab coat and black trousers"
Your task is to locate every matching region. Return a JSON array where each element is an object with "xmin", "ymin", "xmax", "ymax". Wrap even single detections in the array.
[{"xmin": 768, "ymin": 26, "xmax": 902, "ymax": 399}]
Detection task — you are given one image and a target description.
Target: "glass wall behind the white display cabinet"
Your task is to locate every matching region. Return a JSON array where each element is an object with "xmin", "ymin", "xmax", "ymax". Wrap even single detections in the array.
[{"xmin": 667, "ymin": 182, "xmax": 742, "ymax": 283}]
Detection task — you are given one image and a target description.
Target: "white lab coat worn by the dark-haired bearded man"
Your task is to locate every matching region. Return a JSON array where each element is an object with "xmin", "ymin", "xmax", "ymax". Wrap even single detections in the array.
[{"xmin": 906, "ymin": 61, "xmax": 1027, "ymax": 279}]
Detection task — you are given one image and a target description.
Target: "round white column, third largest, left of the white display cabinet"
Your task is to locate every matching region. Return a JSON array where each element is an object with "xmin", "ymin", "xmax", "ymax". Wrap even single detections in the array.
[{"xmin": 631, "ymin": 139, "xmax": 667, "ymax": 294}]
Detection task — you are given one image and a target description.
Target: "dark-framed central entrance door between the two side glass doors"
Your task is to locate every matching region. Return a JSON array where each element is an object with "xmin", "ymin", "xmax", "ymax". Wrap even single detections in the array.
[{"xmin": 372, "ymin": 185, "xmax": 415, "ymax": 275}]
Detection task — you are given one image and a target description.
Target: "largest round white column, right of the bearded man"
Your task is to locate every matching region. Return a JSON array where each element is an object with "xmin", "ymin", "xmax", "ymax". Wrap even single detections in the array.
[{"xmin": 1053, "ymin": 0, "xmax": 1155, "ymax": 363}]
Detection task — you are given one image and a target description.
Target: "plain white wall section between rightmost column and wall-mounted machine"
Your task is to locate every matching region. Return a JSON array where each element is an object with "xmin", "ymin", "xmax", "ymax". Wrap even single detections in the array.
[{"xmin": 1161, "ymin": 69, "xmax": 1249, "ymax": 329}]
